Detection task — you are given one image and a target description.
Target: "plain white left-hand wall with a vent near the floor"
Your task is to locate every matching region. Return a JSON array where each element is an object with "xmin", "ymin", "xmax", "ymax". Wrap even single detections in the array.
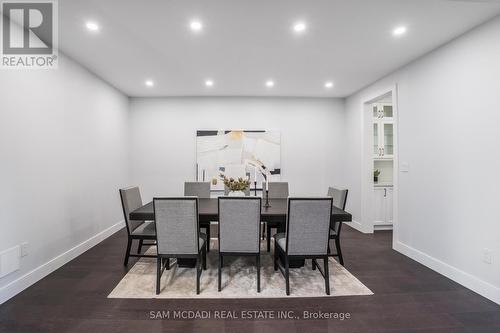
[{"xmin": 0, "ymin": 53, "xmax": 128, "ymax": 303}]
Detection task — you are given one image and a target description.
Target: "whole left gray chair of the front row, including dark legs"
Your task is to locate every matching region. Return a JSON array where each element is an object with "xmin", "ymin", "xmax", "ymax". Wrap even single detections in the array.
[{"xmin": 153, "ymin": 197, "xmax": 207, "ymax": 295}]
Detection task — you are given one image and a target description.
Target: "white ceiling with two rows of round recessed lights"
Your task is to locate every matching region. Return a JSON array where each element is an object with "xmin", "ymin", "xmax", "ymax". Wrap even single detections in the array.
[{"xmin": 59, "ymin": 0, "xmax": 500, "ymax": 97}]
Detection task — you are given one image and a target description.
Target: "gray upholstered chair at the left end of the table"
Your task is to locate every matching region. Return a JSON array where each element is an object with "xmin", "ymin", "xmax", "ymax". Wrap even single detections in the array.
[{"xmin": 120, "ymin": 186, "xmax": 156, "ymax": 266}]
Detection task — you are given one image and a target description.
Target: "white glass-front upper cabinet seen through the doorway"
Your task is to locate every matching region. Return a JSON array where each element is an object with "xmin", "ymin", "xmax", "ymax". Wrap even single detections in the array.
[{"xmin": 373, "ymin": 103, "xmax": 394, "ymax": 159}]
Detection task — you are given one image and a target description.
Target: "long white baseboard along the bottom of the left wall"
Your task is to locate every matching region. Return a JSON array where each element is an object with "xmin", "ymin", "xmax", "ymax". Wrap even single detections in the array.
[{"xmin": 0, "ymin": 220, "xmax": 125, "ymax": 304}]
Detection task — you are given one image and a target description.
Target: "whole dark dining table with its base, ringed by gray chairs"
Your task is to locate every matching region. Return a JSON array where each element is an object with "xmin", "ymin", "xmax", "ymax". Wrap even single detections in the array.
[{"xmin": 129, "ymin": 198, "xmax": 352, "ymax": 267}]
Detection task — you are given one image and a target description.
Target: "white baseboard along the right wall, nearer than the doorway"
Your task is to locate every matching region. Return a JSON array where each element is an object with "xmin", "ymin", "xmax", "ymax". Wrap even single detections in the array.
[{"xmin": 393, "ymin": 242, "xmax": 500, "ymax": 304}]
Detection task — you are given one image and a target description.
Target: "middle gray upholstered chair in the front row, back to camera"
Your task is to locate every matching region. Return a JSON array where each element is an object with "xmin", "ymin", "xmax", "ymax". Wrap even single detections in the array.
[{"xmin": 218, "ymin": 197, "xmax": 262, "ymax": 292}]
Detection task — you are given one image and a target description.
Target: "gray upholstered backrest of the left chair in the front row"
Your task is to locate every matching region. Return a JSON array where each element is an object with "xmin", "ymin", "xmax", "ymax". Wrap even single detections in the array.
[{"xmin": 153, "ymin": 197, "xmax": 199, "ymax": 254}]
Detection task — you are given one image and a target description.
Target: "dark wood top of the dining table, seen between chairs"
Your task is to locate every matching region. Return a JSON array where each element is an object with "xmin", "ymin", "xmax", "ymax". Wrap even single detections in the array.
[{"xmin": 130, "ymin": 198, "xmax": 352, "ymax": 222}]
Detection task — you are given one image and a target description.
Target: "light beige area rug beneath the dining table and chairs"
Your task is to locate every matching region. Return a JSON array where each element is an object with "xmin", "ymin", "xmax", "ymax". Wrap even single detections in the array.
[{"xmin": 108, "ymin": 239, "xmax": 373, "ymax": 298}]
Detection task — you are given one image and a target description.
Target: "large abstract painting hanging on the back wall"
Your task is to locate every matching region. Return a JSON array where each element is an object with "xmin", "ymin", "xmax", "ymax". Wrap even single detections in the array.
[{"xmin": 196, "ymin": 130, "xmax": 281, "ymax": 190}]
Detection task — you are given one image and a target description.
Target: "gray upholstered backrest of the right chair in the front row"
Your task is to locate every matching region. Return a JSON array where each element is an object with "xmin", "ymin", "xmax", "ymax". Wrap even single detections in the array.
[{"xmin": 286, "ymin": 197, "xmax": 332, "ymax": 255}]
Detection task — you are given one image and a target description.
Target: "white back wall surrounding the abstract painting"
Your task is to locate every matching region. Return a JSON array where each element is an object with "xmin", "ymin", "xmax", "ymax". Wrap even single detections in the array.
[{"xmin": 130, "ymin": 98, "xmax": 345, "ymax": 200}]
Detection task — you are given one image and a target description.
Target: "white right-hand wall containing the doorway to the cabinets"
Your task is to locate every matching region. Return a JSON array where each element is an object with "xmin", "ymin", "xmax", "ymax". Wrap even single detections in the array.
[{"xmin": 344, "ymin": 18, "xmax": 500, "ymax": 303}]
